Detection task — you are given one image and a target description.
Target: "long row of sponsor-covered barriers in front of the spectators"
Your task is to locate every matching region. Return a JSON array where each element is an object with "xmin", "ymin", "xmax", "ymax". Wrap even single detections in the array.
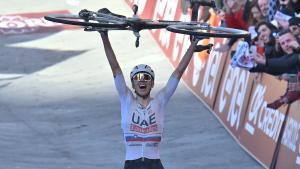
[{"xmin": 125, "ymin": 0, "xmax": 300, "ymax": 169}]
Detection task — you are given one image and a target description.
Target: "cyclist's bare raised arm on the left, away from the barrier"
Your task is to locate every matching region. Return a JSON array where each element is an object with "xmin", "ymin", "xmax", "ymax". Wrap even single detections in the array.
[{"xmin": 100, "ymin": 31, "xmax": 122, "ymax": 77}]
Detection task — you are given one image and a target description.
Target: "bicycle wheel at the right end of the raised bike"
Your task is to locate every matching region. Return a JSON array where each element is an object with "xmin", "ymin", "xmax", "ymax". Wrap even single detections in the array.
[{"xmin": 167, "ymin": 25, "xmax": 250, "ymax": 38}]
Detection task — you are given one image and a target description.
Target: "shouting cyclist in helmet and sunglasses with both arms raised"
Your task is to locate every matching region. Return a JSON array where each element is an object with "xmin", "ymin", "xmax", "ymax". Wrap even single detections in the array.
[{"xmin": 100, "ymin": 31, "xmax": 198, "ymax": 169}]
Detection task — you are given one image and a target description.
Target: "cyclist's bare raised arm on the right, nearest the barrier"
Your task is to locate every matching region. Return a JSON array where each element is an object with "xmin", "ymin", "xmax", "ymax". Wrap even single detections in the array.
[{"xmin": 172, "ymin": 39, "xmax": 198, "ymax": 79}]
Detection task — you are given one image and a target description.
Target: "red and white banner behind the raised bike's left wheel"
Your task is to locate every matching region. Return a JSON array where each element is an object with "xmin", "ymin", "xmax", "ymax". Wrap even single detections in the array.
[{"xmin": 0, "ymin": 10, "xmax": 78, "ymax": 35}]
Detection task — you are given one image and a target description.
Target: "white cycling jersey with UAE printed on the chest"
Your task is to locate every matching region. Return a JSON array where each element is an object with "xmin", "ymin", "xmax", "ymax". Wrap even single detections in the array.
[{"xmin": 115, "ymin": 74, "xmax": 179, "ymax": 160}]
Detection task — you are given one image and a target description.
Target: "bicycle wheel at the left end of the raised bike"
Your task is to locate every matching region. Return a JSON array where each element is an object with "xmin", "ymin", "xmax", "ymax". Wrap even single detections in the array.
[{"xmin": 44, "ymin": 14, "xmax": 127, "ymax": 30}]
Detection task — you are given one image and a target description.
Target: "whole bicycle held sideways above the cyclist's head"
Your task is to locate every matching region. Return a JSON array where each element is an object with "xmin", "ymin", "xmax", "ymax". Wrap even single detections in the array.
[{"xmin": 45, "ymin": 1, "xmax": 249, "ymax": 47}]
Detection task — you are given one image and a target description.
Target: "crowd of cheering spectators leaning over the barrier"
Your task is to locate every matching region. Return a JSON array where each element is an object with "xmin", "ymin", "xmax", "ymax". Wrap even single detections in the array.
[{"xmin": 216, "ymin": 0, "xmax": 300, "ymax": 109}]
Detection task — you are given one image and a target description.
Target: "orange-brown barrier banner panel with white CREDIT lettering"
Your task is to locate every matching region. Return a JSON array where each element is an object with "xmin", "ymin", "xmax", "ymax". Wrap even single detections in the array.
[{"xmin": 239, "ymin": 74, "xmax": 287, "ymax": 166}]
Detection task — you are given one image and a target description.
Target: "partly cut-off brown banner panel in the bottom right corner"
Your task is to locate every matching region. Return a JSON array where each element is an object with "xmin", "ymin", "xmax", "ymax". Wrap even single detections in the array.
[{"xmin": 276, "ymin": 101, "xmax": 300, "ymax": 169}]
